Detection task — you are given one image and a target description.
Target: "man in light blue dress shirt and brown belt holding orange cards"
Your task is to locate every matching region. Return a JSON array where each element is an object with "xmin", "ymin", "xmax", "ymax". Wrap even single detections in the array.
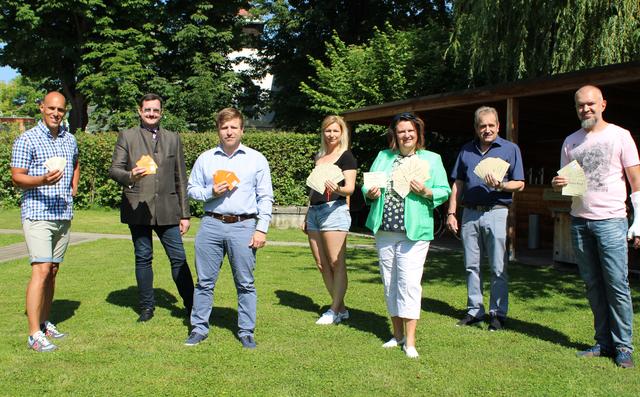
[{"xmin": 185, "ymin": 108, "xmax": 273, "ymax": 349}]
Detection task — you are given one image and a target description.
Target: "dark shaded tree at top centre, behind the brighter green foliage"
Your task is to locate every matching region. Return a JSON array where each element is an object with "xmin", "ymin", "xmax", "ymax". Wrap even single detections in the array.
[{"xmin": 255, "ymin": 0, "xmax": 450, "ymax": 130}]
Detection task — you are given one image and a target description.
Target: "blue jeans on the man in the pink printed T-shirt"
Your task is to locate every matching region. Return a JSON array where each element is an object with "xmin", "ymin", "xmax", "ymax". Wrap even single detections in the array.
[{"xmin": 571, "ymin": 217, "xmax": 633, "ymax": 351}]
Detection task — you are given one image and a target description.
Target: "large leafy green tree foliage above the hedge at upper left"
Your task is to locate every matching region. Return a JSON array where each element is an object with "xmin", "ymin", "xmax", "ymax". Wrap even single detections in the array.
[{"xmin": 0, "ymin": 0, "xmax": 260, "ymax": 131}]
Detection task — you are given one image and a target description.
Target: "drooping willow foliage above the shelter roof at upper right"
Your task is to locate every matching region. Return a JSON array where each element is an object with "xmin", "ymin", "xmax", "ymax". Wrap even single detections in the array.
[{"xmin": 448, "ymin": 0, "xmax": 640, "ymax": 86}]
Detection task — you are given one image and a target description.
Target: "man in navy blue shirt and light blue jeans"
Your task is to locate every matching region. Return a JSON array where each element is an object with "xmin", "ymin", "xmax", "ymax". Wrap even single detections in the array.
[{"xmin": 447, "ymin": 106, "xmax": 524, "ymax": 331}]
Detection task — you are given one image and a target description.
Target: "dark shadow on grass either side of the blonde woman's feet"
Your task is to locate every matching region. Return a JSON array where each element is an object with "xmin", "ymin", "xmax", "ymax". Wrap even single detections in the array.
[{"xmin": 275, "ymin": 290, "xmax": 390, "ymax": 341}]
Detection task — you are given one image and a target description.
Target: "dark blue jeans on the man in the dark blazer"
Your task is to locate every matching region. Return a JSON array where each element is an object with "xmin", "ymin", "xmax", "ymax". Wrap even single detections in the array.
[{"xmin": 129, "ymin": 225, "xmax": 193, "ymax": 313}]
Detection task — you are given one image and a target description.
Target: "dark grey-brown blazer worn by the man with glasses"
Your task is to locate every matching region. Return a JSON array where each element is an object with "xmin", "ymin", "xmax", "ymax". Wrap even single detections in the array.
[{"xmin": 109, "ymin": 127, "xmax": 190, "ymax": 225}]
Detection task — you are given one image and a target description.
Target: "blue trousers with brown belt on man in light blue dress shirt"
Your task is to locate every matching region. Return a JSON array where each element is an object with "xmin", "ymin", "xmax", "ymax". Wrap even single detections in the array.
[{"xmin": 191, "ymin": 216, "xmax": 258, "ymax": 337}]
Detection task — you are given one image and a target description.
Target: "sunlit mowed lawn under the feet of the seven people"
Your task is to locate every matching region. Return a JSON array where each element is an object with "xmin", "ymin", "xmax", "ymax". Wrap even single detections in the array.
[{"xmin": 0, "ymin": 207, "xmax": 640, "ymax": 396}]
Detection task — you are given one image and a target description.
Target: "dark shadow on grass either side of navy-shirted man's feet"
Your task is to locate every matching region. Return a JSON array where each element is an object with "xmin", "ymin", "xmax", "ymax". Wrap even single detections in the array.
[{"xmin": 422, "ymin": 297, "xmax": 588, "ymax": 350}]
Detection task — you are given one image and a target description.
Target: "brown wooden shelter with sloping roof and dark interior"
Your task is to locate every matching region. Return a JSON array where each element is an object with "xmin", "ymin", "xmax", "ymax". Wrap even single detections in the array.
[{"xmin": 343, "ymin": 62, "xmax": 640, "ymax": 262}]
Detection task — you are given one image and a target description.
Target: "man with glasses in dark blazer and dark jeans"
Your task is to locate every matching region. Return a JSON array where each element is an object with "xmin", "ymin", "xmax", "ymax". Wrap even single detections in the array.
[{"xmin": 109, "ymin": 94, "xmax": 193, "ymax": 321}]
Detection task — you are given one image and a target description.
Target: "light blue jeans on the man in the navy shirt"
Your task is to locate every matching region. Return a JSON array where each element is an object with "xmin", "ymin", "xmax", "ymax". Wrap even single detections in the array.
[{"xmin": 460, "ymin": 208, "xmax": 509, "ymax": 317}]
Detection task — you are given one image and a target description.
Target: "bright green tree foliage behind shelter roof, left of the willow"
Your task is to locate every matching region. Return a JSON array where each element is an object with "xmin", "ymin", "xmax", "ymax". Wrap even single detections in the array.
[{"xmin": 300, "ymin": 24, "xmax": 456, "ymax": 116}]
